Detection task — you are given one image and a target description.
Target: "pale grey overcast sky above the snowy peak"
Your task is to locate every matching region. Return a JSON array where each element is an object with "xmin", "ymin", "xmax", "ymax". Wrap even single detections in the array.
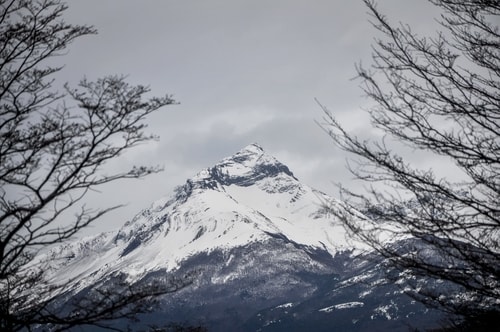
[{"xmin": 57, "ymin": 0, "xmax": 437, "ymax": 232}]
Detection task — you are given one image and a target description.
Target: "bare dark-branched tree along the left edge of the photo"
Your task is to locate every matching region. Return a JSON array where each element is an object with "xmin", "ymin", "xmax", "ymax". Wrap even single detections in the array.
[{"xmin": 0, "ymin": 0, "xmax": 183, "ymax": 331}]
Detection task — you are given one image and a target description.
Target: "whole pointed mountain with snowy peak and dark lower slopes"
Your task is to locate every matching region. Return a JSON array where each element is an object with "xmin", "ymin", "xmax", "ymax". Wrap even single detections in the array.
[{"xmin": 44, "ymin": 144, "xmax": 440, "ymax": 331}]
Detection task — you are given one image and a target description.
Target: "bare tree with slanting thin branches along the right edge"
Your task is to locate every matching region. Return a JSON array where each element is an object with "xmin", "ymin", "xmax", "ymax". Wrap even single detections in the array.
[{"xmin": 322, "ymin": 0, "xmax": 500, "ymax": 324}]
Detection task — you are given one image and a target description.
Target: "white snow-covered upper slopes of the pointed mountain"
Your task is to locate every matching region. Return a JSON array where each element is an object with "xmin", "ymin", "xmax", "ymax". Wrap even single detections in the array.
[{"xmin": 41, "ymin": 144, "xmax": 353, "ymax": 289}]
